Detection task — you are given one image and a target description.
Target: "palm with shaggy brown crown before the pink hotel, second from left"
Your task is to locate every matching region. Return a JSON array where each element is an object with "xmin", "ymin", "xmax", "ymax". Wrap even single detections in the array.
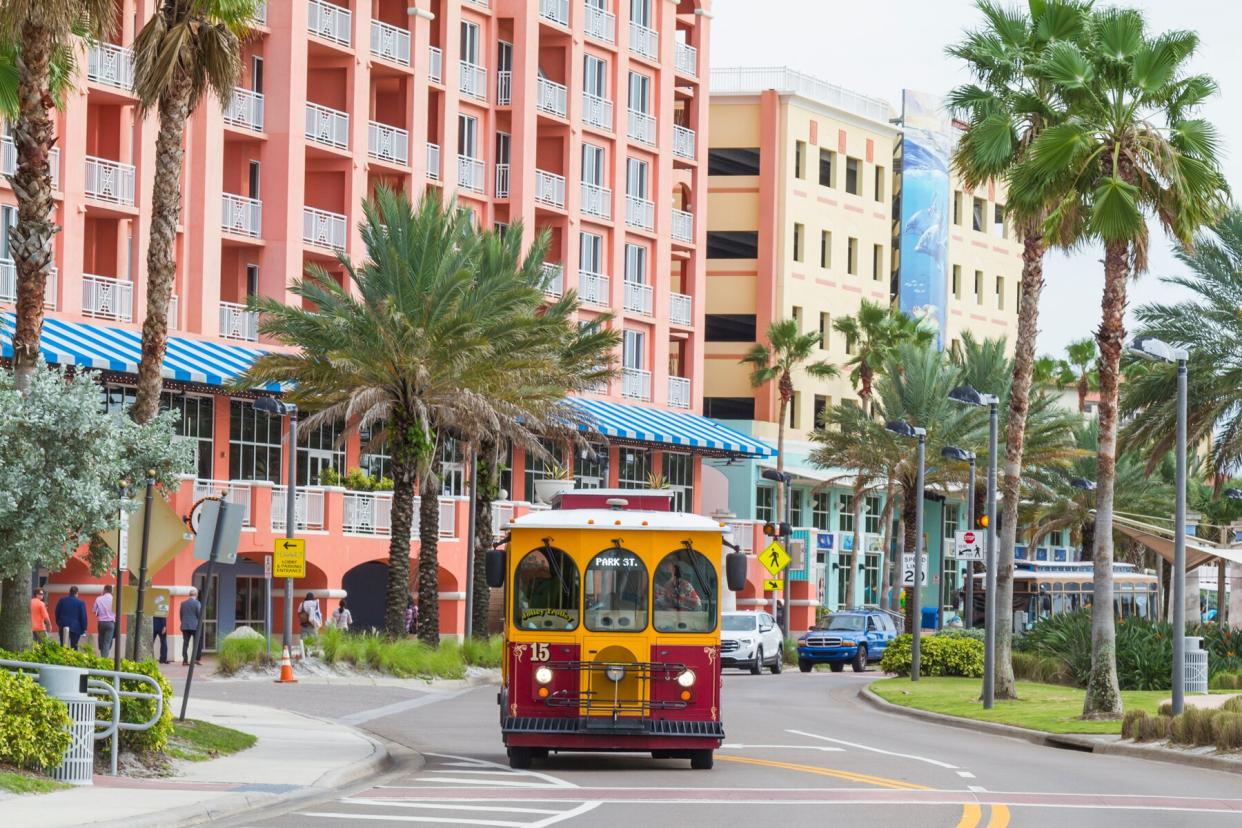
[{"xmin": 130, "ymin": 0, "xmax": 258, "ymax": 422}]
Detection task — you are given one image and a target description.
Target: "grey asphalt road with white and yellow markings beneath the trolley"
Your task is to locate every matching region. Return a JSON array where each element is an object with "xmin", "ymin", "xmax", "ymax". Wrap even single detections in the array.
[{"xmin": 218, "ymin": 672, "xmax": 1242, "ymax": 828}]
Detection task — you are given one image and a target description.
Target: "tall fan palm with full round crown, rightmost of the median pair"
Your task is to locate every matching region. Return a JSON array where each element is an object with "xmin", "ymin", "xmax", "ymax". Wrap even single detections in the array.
[{"xmin": 1011, "ymin": 9, "xmax": 1226, "ymax": 718}]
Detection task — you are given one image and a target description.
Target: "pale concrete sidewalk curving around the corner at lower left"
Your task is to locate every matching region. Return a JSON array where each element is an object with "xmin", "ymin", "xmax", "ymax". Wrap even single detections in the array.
[{"xmin": 0, "ymin": 698, "xmax": 389, "ymax": 828}]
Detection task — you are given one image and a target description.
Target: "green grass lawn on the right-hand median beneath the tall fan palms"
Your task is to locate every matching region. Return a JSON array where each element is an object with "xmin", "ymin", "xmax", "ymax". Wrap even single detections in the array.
[{"xmin": 871, "ymin": 677, "xmax": 1169, "ymax": 734}]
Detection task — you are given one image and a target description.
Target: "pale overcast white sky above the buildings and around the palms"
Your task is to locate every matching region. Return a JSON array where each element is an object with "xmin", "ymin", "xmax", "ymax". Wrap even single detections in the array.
[{"xmin": 710, "ymin": 0, "xmax": 1242, "ymax": 356}]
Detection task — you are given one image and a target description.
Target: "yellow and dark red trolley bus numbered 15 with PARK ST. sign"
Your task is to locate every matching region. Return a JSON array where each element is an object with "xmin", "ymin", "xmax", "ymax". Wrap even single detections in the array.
[{"xmin": 487, "ymin": 489, "xmax": 746, "ymax": 768}]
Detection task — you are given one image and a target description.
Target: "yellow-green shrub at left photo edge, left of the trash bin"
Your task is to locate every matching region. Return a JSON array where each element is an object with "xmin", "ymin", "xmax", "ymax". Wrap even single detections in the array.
[{"xmin": 0, "ymin": 672, "xmax": 71, "ymax": 768}]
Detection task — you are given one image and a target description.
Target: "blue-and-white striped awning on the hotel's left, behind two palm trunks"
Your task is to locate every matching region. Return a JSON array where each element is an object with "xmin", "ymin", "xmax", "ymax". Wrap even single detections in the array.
[{"xmin": 0, "ymin": 313, "xmax": 281, "ymax": 391}]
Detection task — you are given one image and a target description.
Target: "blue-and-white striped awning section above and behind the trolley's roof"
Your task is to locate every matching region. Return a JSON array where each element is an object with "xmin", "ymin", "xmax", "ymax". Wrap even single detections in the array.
[{"xmin": 573, "ymin": 397, "xmax": 776, "ymax": 457}]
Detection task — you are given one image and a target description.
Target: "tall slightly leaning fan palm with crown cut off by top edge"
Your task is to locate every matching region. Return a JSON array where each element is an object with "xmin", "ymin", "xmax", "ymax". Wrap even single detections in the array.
[{"xmin": 949, "ymin": 0, "xmax": 1089, "ymax": 699}]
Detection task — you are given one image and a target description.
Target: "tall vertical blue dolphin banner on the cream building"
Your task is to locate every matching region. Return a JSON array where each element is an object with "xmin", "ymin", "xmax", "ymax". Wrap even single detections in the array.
[{"xmin": 898, "ymin": 89, "xmax": 951, "ymax": 349}]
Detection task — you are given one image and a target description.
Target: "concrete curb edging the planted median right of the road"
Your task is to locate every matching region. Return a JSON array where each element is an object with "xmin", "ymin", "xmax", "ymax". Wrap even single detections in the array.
[{"xmin": 858, "ymin": 686, "xmax": 1242, "ymax": 773}]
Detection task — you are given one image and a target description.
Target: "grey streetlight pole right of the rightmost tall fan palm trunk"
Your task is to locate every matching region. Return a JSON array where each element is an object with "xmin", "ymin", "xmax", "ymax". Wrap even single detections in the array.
[{"xmin": 1130, "ymin": 336, "xmax": 1189, "ymax": 716}]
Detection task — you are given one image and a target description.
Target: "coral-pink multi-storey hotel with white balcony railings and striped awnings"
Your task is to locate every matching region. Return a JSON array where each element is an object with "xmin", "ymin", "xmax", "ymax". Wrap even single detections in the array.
[{"xmin": 0, "ymin": 0, "xmax": 770, "ymax": 646}]
